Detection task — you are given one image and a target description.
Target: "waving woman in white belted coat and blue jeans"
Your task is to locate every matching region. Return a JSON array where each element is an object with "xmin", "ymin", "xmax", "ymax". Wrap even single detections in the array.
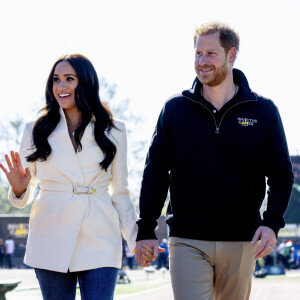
[{"xmin": 0, "ymin": 54, "xmax": 136, "ymax": 300}]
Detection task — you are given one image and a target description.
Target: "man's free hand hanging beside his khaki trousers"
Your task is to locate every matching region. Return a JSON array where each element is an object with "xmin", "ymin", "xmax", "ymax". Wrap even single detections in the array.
[{"xmin": 251, "ymin": 226, "xmax": 276, "ymax": 259}]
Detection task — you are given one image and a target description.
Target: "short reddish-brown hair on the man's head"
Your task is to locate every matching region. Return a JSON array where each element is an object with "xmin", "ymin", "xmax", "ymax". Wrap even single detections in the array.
[{"xmin": 194, "ymin": 21, "xmax": 240, "ymax": 54}]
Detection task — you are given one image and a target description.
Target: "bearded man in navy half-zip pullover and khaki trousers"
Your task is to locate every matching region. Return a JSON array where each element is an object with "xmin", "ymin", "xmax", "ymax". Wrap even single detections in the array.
[{"xmin": 136, "ymin": 22, "xmax": 293, "ymax": 300}]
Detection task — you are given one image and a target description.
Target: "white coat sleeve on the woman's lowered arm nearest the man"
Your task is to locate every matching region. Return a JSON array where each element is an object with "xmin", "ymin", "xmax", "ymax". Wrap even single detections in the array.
[{"xmin": 110, "ymin": 122, "xmax": 137, "ymax": 251}]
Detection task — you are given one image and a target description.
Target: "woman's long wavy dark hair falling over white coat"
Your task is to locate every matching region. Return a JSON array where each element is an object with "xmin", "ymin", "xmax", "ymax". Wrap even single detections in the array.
[{"xmin": 26, "ymin": 54, "xmax": 117, "ymax": 171}]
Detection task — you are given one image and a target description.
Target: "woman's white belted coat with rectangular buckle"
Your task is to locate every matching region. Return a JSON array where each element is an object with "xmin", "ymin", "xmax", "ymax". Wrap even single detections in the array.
[{"xmin": 9, "ymin": 109, "xmax": 137, "ymax": 272}]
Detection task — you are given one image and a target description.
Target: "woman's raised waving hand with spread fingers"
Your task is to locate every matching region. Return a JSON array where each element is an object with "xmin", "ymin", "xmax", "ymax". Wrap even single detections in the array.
[{"xmin": 0, "ymin": 151, "xmax": 31, "ymax": 198}]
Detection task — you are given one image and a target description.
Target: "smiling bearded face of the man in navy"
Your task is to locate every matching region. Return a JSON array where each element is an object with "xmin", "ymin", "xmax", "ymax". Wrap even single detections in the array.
[{"xmin": 195, "ymin": 32, "xmax": 230, "ymax": 86}]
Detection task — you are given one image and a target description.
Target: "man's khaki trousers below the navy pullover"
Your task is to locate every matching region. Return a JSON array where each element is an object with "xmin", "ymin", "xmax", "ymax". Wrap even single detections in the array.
[{"xmin": 169, "ymin": 237, "xmax": 258, "ymax": 300}]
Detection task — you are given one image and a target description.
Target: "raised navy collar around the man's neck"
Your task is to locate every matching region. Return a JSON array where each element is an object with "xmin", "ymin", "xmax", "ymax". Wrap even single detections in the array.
[{"xmin": 182, "ymin": 69, "xmax": 257, "ymax": 102}]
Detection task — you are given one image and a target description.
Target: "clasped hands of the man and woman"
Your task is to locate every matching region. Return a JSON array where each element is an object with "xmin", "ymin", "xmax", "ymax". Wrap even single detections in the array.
[{"xmin": 135, "ymin": 240, "xmax": 166, "ymax": 267}]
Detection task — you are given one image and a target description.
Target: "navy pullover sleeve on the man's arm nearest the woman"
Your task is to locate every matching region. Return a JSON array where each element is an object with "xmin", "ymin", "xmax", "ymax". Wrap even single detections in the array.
[{"xmin": 137, "ymin": 104, "xmax": 173, "ymax": 241}]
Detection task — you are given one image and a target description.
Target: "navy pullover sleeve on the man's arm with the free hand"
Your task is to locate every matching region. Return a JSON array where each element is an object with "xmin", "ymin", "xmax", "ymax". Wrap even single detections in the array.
[{"xmin": 262, "ymin": 107, "xmax": 294, "ymax": 236}]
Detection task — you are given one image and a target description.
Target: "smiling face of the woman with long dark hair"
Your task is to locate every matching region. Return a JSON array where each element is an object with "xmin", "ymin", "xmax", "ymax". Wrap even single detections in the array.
[{"xmin": 52, "ymin": 61, "xmax": 78, "ymax": 110}]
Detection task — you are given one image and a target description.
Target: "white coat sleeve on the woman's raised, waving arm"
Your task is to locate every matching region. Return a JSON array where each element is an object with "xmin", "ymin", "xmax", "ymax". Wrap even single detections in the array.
[{"xmin": 8, "ymin": 123, "xmax": 36, "ymax": 208}]
